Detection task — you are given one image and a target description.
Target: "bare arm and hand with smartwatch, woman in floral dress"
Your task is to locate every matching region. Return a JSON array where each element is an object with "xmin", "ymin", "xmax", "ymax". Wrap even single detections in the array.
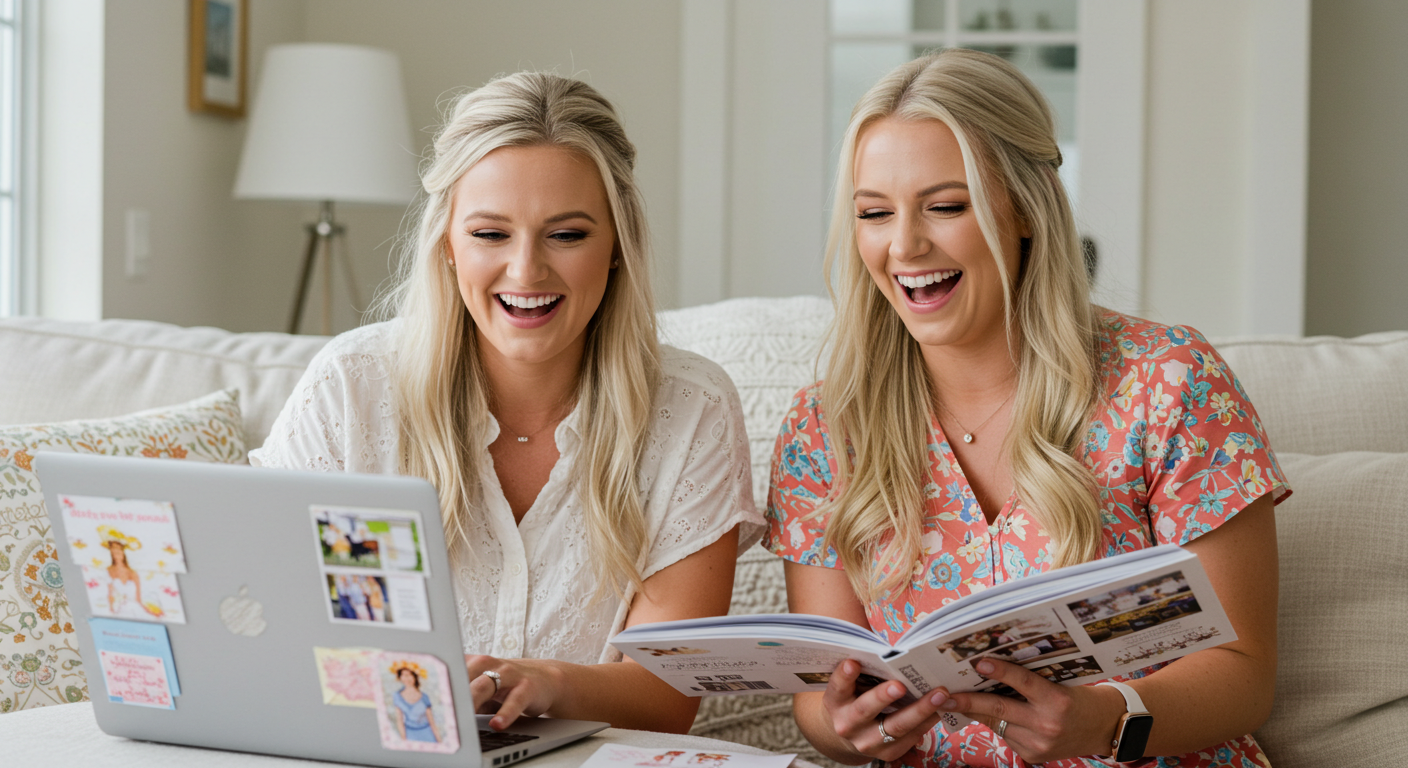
[{"xmin": 945, "ymin": 495, "xmax": 1278, "ymax": 762}]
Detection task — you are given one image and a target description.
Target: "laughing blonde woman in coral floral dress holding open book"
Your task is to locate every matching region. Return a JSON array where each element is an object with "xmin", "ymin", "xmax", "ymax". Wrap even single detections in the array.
[{"xmin": 765, "ymin": 49, "xmax": 1290, "ymax": 768}]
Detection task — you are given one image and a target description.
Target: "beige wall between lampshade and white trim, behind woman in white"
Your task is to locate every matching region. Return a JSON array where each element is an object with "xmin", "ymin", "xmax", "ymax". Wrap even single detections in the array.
[{"xmin": 306, "ymin": 0, "xmax": 680, "ymax": 307}]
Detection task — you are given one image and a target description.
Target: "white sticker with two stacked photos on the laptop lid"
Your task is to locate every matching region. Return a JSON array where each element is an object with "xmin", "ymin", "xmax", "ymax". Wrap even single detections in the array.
[{"xmin": 308, "ymin": 504, "xmax": 431, "ymax": 631}]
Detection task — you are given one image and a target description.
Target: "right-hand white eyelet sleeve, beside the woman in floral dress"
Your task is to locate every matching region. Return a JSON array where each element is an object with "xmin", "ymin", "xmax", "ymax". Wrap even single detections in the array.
[{"xmin": 641, "ymin": 351, "xmax": 763, "ymax": 578}]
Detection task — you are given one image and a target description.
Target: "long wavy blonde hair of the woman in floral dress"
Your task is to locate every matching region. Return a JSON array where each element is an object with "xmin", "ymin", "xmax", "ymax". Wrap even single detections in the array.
[{"xmin": 818, "ymin": 49, "xmax": 1102, "ymax": 599}]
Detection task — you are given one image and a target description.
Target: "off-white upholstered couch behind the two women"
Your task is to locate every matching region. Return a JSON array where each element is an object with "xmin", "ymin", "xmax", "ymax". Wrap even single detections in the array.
[{"xmin": 0, "ymin": 297, "xmax": 1408, "ymax": 768}]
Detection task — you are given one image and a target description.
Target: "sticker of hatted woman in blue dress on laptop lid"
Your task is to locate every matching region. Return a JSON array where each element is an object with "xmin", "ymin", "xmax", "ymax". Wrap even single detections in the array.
[{"xmin": 370, "ymin": 651, "xmax": 459, "ymax": 754}]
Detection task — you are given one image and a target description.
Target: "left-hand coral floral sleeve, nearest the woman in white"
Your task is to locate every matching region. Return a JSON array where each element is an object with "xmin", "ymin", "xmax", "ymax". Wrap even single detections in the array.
[{"xmin": 763, "ymin": 383, "xmax": 841, "ymax": 568}]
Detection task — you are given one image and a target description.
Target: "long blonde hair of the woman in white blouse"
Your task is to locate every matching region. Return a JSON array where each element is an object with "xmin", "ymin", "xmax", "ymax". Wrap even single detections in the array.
[{"xmin": 383, "ymin": 72, "xmax": 660, "ymax": 593}]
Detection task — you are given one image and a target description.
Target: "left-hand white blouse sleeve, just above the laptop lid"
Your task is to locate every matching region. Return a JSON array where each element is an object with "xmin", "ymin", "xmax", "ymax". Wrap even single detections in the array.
[{"xmin": 249, "ymin": 324, "xmax": 400, "ymax": 473}]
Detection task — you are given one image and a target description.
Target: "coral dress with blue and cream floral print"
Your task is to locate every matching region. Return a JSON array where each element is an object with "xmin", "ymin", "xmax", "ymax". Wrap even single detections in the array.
[{"xmin": 763, "ymin": 313, "xmax": 1290, "ymax": 768}]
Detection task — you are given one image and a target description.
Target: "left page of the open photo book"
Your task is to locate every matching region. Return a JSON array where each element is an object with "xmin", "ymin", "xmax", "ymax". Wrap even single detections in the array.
[{"xmin": 612, "ymin": 634, "xmax": 895, "ymax": 696}]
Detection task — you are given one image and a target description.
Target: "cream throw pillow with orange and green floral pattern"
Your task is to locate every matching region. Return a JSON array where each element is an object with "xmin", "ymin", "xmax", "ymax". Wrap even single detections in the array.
[{"xmin": 0, "ymin": 390, "xmax": 245, "ymax": 714}]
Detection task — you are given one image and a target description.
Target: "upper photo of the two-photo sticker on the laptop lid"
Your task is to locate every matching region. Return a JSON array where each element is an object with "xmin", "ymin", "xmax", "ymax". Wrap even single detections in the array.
[{"xmin": 313, "ymin": 507, "xmax": 427, "ymax": 575}]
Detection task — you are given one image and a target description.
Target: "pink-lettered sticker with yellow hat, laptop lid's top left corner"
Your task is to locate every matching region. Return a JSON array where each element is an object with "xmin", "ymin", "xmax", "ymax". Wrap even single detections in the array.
[{"xmin": 59, "ymin": 495, "xmax": 186, "ymax": 574}]
